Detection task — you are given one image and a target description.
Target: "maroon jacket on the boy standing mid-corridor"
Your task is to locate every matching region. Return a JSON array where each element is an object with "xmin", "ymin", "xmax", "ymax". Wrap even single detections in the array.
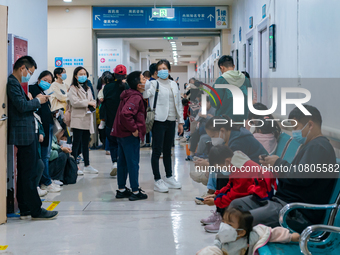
[{"xmin": 111, "ymin": 89, "xmax": 147, "ymax": 141}]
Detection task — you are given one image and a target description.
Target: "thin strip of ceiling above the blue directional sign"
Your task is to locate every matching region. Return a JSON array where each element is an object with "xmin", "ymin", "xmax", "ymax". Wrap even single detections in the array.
[{"xmin": 48, "ymin": 0, "xmax": 234, "ymax": 6}]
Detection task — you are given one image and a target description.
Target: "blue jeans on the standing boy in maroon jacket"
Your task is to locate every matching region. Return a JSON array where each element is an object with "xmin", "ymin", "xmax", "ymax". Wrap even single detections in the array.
[{"xmin": 117, "ymin": 135, "xmax": 140, "ymax": 192}]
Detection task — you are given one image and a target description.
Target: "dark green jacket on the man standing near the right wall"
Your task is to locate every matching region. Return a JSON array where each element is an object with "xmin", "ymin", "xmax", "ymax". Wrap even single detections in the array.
[{"xmin": 209, "ymin": 73, "xmax": 251, "ymax": 121}]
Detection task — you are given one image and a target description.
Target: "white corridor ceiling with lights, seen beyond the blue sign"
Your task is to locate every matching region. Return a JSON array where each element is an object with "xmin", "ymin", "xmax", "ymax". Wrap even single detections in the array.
[{"xmin": 124, "ymin": 37, "xmax": 213, "ymax": 66}]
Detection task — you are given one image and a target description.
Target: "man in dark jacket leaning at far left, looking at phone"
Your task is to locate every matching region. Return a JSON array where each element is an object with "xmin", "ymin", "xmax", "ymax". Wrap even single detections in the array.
[{"xmin": 7, "ymin": 56, "xmax": 58, "ymax": 219}]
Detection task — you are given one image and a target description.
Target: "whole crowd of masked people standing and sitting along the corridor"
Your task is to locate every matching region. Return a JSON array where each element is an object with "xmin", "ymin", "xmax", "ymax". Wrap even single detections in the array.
[{"xmin": 7, "ymin": 56, "xmax": 336, "ymax": 255}]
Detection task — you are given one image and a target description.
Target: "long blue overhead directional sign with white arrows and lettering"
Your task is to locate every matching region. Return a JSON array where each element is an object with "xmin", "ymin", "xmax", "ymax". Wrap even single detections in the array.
[{"xmin": 92, "ymin": 6, "xmax": 228, "ymax": 29}]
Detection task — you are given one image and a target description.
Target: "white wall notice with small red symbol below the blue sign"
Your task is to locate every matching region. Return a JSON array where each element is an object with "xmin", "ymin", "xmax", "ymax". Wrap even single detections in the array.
[{"xmin": 98, "ymin": 47, "xmax": 122, "ymax": 76}]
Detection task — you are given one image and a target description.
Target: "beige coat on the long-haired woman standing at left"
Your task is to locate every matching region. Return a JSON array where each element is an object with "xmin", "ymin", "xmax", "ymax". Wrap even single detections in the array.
[{"xmin": 68, "ymin": 86, "xmax": 95, "ymax": 134}]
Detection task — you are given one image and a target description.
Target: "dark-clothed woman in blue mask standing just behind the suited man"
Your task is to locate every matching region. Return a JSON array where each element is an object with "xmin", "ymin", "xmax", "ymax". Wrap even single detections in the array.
[{"xmin": 29, "ymin": 71, "xmax": 61, "ymax": 193}]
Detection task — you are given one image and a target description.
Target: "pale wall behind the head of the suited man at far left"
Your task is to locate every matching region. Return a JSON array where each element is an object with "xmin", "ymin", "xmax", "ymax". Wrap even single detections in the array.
[{"xmin": 0, "ymin": 0, "xmax": 47, "ymax": 83}]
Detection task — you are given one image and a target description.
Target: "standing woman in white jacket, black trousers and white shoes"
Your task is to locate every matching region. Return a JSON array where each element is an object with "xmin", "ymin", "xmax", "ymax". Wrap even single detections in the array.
[{"xmin": 144, "ymin": 59, "xmax": 184, "ymax": 192}]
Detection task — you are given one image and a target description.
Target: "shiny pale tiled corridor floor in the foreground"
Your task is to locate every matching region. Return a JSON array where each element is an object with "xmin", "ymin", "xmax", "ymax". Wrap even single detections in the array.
[{"xmin": 0, "ymin": 145, "xmax": 215, "ymax": 255}]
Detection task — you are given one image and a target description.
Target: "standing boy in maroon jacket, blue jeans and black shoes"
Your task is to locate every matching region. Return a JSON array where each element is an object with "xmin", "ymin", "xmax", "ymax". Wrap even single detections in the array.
[{"xmin": 111, "ymin": 71, "xmax": 148, "ymax": 201}]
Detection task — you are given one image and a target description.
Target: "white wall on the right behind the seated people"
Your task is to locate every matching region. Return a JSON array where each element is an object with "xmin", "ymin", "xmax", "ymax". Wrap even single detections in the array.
[{"xmin": 231, "ymin": 0, "xmax": 340, "ymax": 137}]
